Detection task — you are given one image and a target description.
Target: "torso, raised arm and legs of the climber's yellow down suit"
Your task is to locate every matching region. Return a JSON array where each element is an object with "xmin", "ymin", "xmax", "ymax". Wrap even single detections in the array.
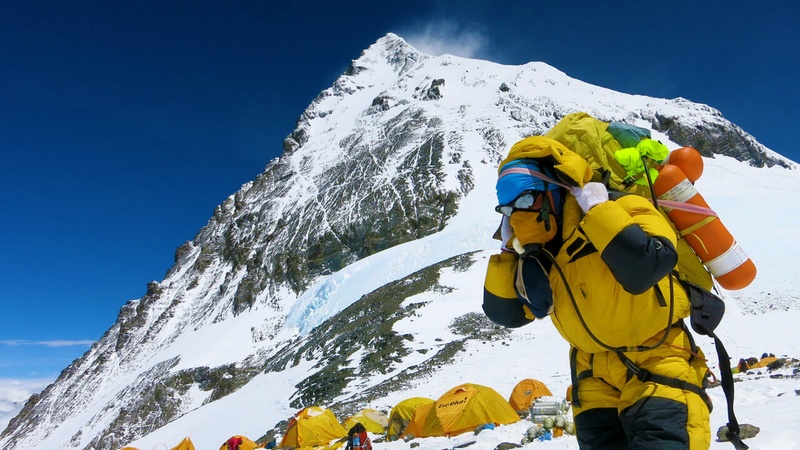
[{"xmin": 550, "ymin": 195, "xmax": 711, "ymax": 450}]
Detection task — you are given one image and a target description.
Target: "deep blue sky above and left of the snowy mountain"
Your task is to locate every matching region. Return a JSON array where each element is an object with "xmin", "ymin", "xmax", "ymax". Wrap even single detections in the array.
[{"xmin": 0, "ymin": 0, "xmax": 800, "ymax": 379}]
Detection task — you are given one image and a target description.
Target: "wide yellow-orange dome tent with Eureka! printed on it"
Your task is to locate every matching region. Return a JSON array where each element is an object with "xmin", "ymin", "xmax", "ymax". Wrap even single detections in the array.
[{"xmin": 403, "ymin": 383, "xmax": 519, "ymax": 437}]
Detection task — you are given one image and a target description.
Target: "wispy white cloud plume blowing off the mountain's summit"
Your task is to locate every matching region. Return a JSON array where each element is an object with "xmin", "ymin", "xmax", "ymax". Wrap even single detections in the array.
[{"xmin": 398, "ymin": 20, "xmax": 488, "ymax": 58}]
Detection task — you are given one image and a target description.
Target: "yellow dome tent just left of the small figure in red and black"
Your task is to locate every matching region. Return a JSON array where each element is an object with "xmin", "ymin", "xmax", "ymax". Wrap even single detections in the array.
[{"xmin": 278, "ymin": 406, "xmax": 347, "ymax": 449}]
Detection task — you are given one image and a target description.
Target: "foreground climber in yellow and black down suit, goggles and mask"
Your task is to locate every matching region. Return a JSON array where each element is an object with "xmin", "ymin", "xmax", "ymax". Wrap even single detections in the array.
[{"xmin": 483, "ymin": 136, "xmax": 711, "ymax": 450}]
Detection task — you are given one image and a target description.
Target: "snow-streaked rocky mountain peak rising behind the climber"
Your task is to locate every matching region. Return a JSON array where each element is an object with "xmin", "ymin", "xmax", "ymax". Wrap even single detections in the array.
[{"xmin": 0, "ymin": 34, "xmax": 796, "ymax": 450}]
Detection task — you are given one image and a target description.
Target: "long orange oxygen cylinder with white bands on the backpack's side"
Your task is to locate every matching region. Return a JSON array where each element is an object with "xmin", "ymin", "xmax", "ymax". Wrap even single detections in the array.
[{"xmin": 653, "ymin": 164, "xmax": 756, "ymax": 290}]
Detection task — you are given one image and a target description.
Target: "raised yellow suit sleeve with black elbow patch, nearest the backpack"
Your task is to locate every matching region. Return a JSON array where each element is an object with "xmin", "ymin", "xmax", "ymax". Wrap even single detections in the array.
[{"xmin": 581, "ymin": 195, "xmax": 678, "ymax": 294}]
